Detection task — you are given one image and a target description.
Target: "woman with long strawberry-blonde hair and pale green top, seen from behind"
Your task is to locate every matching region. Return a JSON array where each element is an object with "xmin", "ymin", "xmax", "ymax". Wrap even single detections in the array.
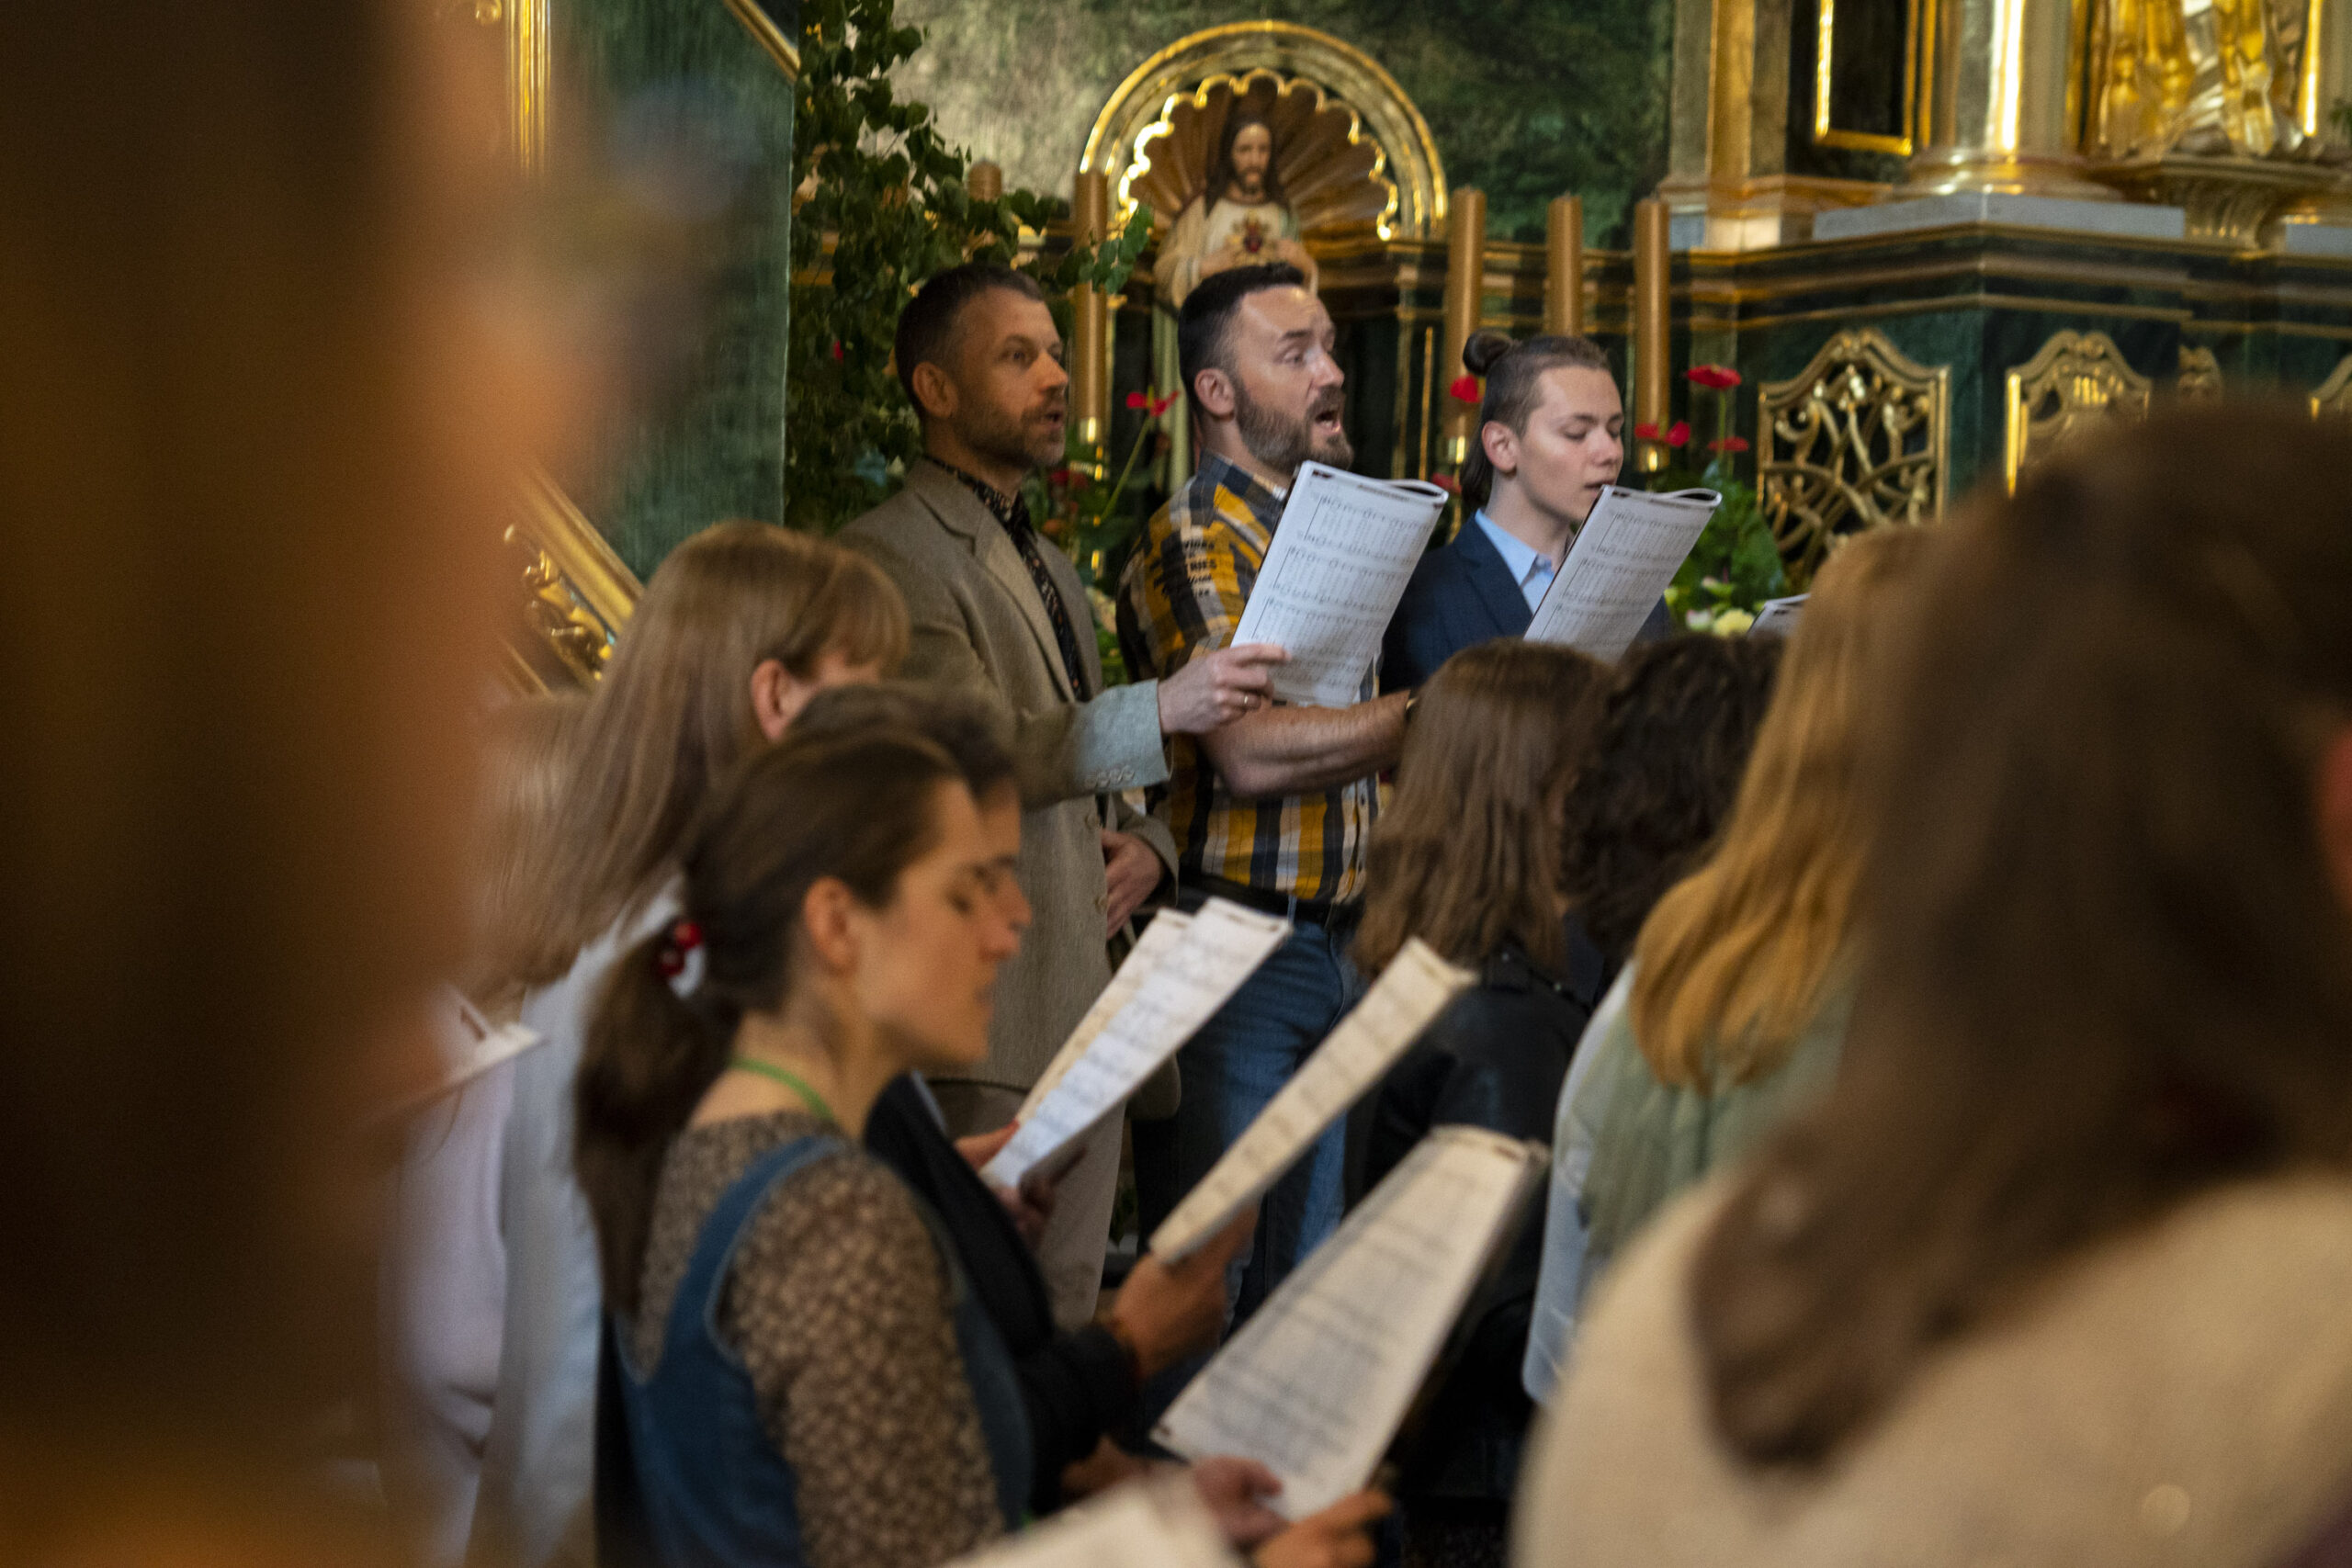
[{"xmin": 1526, "ymin": 529, "xmax": 1936, "ymax": 1399}]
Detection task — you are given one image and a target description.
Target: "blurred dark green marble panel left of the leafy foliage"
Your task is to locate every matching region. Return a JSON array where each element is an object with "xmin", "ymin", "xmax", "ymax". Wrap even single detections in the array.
[{"xmin": 550, "ymin": 0, "xmax": 797, "ymax": 576}]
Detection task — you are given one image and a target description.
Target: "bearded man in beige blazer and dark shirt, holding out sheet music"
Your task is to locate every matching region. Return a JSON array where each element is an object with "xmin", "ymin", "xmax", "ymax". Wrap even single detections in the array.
[{"xmin": 842, "ymin": 264, "xmax": 1282, "ymax": 1325}]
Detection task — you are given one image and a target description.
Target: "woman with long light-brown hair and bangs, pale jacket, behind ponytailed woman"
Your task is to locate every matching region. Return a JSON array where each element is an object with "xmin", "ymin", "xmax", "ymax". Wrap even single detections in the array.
[{"xmin": 470, "ymin": 522, "xmax": 908, "ymax": 1568}]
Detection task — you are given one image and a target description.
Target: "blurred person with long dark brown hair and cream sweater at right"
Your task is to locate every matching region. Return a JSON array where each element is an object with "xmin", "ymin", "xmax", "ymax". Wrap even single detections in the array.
[{"xmin": 1515, "ymin": 407, "xmax": 2352, "ymax": 1568}]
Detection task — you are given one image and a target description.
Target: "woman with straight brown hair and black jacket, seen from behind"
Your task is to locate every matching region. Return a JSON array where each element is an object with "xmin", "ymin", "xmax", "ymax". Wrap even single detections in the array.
[{"xmin": 1355, "ymin": 637, "xmax": 1609, "ymax": 1563}]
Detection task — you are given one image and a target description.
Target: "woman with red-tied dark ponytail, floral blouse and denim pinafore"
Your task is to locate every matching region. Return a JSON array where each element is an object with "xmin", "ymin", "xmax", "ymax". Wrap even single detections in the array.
[{"xmin": 574, "ymin": 728, "xmax": 1030, "ymax": 1568}]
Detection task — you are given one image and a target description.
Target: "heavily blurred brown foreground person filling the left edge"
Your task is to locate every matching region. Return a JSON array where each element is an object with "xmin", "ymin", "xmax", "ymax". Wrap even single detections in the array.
[{"xmin": 0, "ymin": 0, "xmax": 593, "ymax": 1563}]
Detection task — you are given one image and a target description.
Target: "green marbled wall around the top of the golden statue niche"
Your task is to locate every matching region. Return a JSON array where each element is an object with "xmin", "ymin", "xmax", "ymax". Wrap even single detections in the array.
[{"xmin": 888, "ymin": 0, "xmax": 1672, "ymax": 247}]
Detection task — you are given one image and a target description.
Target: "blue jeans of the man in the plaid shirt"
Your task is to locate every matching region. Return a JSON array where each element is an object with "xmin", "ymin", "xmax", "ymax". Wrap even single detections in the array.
[{"xmin": 1146, "ymin": 919, "xmax": 1364, "ymax": 1324}]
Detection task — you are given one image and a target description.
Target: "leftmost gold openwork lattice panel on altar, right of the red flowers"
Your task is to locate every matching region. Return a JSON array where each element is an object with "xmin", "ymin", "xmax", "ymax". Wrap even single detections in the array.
[{"xmin": 1757, "ymin": 327, "xmax": 1952, "ymax": 588}]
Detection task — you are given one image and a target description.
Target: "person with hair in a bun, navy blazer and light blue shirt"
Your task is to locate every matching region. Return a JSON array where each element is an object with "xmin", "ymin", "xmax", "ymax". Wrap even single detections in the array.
[{"xmin": 1381, "ymin": 332, "xmax": 1668, "ymax": 691}]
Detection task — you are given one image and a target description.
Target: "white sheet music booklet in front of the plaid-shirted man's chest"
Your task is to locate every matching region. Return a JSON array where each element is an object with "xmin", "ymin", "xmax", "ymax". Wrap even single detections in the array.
[{"xmin": 1232, "ymin": 463, "xmax": 1452, "ymax": 707}]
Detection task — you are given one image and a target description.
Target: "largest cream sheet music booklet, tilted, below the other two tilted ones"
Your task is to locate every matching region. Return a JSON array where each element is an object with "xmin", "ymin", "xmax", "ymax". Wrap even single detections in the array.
[{"xmin": 1152, "ymin": 1126, "xmax": 1547, "ymax": 1518}]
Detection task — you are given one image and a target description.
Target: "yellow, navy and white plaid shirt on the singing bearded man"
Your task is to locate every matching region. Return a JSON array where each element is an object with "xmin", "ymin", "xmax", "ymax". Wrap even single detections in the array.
[{"xmin": 1120, "ymin": 454, "xmax": 1376, "ymax": 900}]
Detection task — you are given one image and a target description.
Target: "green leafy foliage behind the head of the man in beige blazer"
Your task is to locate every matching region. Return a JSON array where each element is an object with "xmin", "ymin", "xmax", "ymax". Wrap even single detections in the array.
[{"xmin": 783, "ymin": 0, "xmax": 1150, "ymax": 534}]
